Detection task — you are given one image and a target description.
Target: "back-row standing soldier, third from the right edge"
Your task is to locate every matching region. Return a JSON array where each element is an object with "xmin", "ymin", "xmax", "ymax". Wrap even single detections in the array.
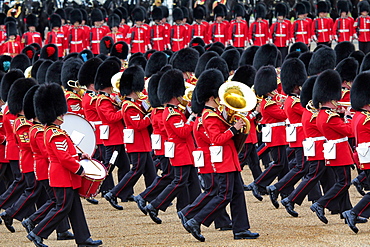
[{"xmin": 311, "ymin": 1, "xmax": 333, "ymax": 47}]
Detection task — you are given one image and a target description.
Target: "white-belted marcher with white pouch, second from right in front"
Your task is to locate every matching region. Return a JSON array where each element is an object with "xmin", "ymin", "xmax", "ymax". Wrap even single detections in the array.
[{"xmin": 310, "ymin": 69, "xmax": 354, "ymax": 224}]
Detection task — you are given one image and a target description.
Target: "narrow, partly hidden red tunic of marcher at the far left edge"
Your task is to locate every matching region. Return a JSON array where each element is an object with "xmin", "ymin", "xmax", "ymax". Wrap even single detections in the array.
[{"xmin": 3, "ymin": 106, "xmax": 19, "ymax": 160}]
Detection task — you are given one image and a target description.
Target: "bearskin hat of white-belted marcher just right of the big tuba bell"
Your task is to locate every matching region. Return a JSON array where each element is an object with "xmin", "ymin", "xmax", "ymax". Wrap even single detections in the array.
[{"xmin": 254, "ymin": 65, "xmax": 277, "ymax": 96}]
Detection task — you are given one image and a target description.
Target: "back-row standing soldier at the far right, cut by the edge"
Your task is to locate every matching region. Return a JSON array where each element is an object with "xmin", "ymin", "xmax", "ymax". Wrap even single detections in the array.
[{"xmin": 354, "ymin": 1, "xmax": 370, "ymax": 54}]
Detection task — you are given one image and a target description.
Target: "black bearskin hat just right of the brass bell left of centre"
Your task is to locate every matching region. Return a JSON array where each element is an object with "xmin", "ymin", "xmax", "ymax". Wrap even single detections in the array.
[{"xmin": 119, "ymin": 66, "xmax": 144, "ymax": 95}]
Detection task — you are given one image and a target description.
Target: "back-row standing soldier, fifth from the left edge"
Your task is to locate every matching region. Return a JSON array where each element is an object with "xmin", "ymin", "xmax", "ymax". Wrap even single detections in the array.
[{"xmin": 89, "ymin": 8, "xmax": 107, "ymax": 55}]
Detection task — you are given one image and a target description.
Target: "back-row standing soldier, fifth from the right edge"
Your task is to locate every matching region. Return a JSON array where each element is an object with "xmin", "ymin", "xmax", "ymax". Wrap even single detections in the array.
[{"xmin": 270, "ymin": 3, "xmax": 291, "ymax": 61}]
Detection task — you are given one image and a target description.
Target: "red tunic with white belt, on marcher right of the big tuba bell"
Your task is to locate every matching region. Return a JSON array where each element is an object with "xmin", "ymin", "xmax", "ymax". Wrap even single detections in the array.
[{"xmin": 260, "ymin": 96, "xmax": 287, "ymax": 147}]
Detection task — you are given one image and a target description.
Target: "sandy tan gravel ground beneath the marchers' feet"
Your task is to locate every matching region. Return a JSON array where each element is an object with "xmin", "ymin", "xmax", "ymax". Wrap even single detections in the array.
[{"xmin": 0, "ymin": 169, "xmax": 370, "ymax": 246}]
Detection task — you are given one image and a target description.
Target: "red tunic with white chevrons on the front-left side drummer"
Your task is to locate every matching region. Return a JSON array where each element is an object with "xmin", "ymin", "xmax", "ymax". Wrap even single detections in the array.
[{"xmin": 44, "ymin": 125, "xmax": 82, "ymax": 189}]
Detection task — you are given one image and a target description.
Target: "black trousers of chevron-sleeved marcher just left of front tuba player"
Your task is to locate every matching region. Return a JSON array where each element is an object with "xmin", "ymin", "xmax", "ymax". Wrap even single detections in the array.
[{"xmin": 150, "ymin": 165, "xmax": 200, "ymax": 211}]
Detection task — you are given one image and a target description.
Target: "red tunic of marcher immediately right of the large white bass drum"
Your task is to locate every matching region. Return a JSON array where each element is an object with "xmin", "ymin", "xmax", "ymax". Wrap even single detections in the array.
[{"xmin": 82, "ymin": 91, "xmax": 103, "ymax": 145}]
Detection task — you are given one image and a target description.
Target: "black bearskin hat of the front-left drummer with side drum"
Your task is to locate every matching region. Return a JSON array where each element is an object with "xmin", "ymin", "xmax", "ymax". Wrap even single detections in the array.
[{"xmin": 33, "ymin": 83, "xmax": 68, "ymax": 125}]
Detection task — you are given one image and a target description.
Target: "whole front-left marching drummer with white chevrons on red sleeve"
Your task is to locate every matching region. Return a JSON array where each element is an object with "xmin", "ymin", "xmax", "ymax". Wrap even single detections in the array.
[{"xmin": 27, "ymin": 83, "xmax": 102, "ymax": 247}]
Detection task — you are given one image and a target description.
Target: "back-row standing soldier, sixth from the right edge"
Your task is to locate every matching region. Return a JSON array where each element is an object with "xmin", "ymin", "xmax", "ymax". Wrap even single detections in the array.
[{"xmin": 248, "ymin": 3, "xmax": 269, "ymax": 46}]
